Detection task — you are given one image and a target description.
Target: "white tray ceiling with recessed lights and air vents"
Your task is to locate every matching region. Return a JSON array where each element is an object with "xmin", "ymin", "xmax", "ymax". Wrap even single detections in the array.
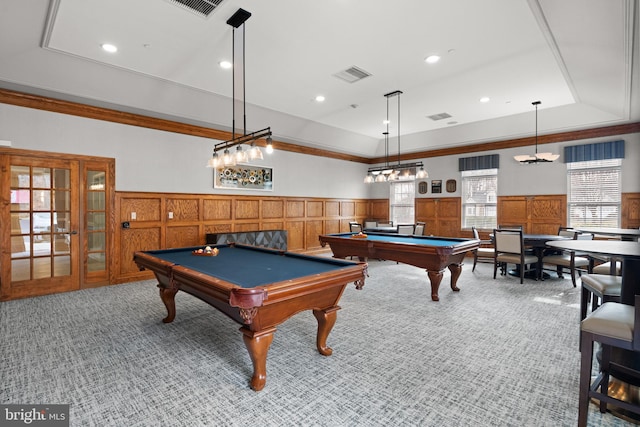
[{"xmin": 0, "ymin": 0, "xmax": 640, "ymax": 157}]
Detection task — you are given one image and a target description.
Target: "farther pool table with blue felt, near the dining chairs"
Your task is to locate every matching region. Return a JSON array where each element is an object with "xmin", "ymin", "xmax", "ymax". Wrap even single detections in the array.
[{"xmin": 320, "ymin": 233, "xmax": 480, "ymax": 301}]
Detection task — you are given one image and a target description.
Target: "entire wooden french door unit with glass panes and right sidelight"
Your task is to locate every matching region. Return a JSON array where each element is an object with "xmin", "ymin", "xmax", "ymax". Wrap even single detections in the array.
[{"xmin": 0, "ymin": 151, "xmax": 111, "ymax": 300}]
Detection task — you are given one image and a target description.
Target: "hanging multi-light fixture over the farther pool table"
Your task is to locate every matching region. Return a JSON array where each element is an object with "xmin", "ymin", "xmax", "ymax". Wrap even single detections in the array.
[{"xmin": 364, "ymin": 90, "xmax": 429, "ymax": 184}]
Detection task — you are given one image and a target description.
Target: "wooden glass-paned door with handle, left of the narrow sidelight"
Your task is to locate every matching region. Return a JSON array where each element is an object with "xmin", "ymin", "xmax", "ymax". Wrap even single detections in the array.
[{"xmin": 5, "ymin": 156, "xmax": 79, "ymax": 296}]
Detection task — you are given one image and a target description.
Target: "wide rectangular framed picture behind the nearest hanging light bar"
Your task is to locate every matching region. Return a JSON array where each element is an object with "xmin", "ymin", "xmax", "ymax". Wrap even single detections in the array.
[{"xmin": 213, "ymin": 165, "xmax": 273, "ymax": 191}]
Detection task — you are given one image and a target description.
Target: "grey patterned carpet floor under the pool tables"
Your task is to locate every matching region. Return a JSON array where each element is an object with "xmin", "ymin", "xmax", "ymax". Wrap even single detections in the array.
[{"xmin": 0, "ymin": 261, "xmax": 631, "ymax": 427}]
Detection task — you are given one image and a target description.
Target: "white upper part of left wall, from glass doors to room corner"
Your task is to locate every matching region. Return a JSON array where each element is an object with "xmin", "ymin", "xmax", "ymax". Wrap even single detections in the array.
[{"xmin": 0, "ymin": 104, "xmax": 369, "ymax": 198}]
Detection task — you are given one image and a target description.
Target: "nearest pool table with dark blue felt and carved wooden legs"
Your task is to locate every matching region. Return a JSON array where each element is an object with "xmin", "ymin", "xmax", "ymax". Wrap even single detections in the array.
[{"xmin": 133, "ymin": 244, "xmax": 366, "ymax": 391}]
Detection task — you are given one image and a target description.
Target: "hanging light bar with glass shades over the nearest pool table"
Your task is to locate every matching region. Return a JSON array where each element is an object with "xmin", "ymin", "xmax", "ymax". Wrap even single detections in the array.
[{"xmin": 207, "ymin": 9, "xmax": 273, "ymax": 168}]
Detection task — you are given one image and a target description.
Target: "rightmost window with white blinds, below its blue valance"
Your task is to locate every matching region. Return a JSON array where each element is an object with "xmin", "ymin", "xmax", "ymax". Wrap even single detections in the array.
[{"xmin": 567, "ymin": 159, "xmax": 622, "ymax": 228}]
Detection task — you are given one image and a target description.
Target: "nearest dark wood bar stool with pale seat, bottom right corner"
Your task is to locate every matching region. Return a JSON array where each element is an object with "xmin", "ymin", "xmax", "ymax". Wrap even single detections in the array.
[{"xmin": 578, "ymin": 295, "xmax": 640, "ymax": 427}]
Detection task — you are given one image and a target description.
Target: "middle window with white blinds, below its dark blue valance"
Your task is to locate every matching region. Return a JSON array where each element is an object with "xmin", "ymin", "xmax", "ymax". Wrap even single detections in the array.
[{"xmin": 462, "ymin": 169, "xmax": 498, "ymax": 230}]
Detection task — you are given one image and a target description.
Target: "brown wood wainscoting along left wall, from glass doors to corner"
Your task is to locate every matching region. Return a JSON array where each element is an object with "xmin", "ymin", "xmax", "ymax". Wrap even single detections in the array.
[{"xmin": 112, "ymin": 192, "xmax": 372, "ymax": 283}]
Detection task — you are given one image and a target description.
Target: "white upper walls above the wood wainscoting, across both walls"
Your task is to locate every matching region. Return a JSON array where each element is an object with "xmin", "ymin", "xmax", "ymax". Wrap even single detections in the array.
[{"xmin": 0, "ymin": 104, "xmax": 640, "ymax": 198}]
